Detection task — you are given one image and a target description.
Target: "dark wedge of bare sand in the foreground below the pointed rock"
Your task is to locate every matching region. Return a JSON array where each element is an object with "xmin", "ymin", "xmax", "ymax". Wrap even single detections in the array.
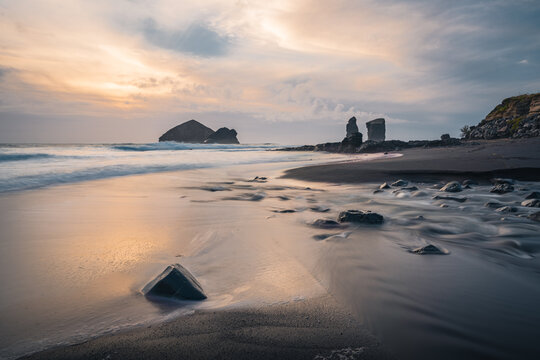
[{"xmin": 24, "ymin": 296, "xmax": 393, "ymax": 360}]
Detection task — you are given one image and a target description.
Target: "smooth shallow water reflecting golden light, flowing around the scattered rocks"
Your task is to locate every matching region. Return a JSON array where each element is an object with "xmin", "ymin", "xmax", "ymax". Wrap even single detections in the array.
[{"xmin": 0, "ymin": 150, "xmax": 540, "ymax": 359}]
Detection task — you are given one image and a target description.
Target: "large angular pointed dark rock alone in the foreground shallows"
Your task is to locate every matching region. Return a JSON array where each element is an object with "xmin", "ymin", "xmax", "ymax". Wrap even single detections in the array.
[{"xmin": 142, "ymin": 264, "xmax": 206, "ymax": 300}]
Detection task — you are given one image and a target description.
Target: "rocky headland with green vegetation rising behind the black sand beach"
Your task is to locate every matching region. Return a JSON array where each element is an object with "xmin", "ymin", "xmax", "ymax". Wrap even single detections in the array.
[{"xmin": 461, "ymin": 93, "xmax": 540, "ymax": 140}]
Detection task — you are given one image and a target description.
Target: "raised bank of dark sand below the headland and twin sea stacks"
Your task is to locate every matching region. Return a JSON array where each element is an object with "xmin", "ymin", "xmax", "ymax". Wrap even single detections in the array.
[{"xmin": 284, "ymin": 138, "xmax": 540, "ymax": 183}]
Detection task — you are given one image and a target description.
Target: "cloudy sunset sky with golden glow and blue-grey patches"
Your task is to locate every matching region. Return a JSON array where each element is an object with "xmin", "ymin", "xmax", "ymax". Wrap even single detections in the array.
[{"xmin": 0, "ymin": 0, "xmax": 540, "ymax": 144}]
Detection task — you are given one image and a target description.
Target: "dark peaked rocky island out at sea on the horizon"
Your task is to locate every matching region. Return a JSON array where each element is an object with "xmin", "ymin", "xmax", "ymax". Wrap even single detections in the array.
[{"xmin": 159, "ymin": 120, "xmax": 240, "ymax": 144}]
